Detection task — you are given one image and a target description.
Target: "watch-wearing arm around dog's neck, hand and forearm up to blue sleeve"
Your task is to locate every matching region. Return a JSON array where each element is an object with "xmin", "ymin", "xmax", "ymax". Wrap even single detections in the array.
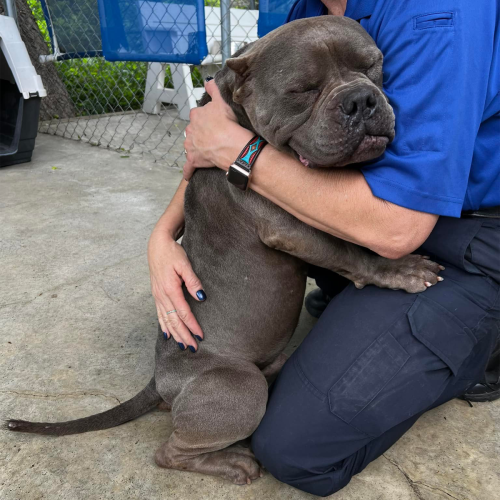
[{"xmin": 184, "ymin": 80, "xmax": 438, "ymax": 259}]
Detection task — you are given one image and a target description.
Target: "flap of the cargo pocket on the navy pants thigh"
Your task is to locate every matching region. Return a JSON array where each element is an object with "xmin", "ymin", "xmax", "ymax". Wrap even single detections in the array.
[{"xmin": 408, "ymin": 295, "xmax": 477, "ymax": 375}]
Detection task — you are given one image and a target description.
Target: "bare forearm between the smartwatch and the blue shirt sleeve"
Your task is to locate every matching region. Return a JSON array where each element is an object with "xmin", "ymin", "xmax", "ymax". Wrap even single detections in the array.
[{"xmin": 248, "ymin": 148, "xmax": 438, "ymax": 259}]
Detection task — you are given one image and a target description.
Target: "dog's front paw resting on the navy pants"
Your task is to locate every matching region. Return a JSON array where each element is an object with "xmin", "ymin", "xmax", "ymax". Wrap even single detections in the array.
[{"xmin": 354, "ymin": 254, "xmax": 444, "ymax": 293}]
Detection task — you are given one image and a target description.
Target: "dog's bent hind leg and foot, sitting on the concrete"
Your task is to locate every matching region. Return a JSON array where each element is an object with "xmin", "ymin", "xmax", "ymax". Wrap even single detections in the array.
[{"xmin": 155, "ymin": 365, "xmax": 268, "ymax": 484}]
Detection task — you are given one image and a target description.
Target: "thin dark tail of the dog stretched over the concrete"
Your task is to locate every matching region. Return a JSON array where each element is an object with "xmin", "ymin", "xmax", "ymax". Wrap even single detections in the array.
[{"xmin": 5, "ymin": 378, "xmax": 162, "ymax": 436}]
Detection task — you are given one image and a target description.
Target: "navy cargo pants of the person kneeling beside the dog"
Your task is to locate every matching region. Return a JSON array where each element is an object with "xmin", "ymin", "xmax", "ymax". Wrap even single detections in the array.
[{"xmin": 253, "ymin": 217, "xmax": 500, "ymax": 496}]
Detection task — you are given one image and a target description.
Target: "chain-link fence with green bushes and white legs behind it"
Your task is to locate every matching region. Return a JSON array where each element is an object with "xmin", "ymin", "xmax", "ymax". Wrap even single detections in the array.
[{"xmin": 27, "ymin": 0, "xmax": 258, "ymax": 167}]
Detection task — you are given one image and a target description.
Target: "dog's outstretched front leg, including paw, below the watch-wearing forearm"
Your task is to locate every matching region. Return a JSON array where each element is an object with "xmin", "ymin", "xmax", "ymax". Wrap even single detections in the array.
[{"xmin": 258, "ymin": 209, "xmax": 444, "ymax": 293}]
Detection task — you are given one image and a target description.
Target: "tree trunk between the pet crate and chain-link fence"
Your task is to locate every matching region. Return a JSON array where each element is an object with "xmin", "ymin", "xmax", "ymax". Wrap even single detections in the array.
[{"xmin": 0, "ymin": 0, "xmax": 76, "ymax": 120}]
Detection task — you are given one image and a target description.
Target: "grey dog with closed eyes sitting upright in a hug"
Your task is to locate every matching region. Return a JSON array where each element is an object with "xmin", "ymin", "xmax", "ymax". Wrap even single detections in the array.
[{"xmin": 7, "ymin": 16, "xmax": 440, "ymax": 484}]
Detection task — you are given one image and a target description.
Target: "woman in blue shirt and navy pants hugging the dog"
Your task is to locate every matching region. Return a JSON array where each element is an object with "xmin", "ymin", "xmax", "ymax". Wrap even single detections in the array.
[{"xmin": 148, "ymin": 0, "xmax": 500, "ymax": 496}]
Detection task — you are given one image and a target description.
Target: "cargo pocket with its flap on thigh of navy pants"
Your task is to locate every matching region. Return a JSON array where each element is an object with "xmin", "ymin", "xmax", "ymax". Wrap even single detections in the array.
[{"xmin": 328, "ymin": 294, "xmax": 477, "ymax": 437}]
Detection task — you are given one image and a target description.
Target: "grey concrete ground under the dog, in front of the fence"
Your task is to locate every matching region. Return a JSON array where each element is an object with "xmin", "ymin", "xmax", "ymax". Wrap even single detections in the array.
[{"xmin": 0, "ymin": 135, "xmax": 500, "ymax": 500}]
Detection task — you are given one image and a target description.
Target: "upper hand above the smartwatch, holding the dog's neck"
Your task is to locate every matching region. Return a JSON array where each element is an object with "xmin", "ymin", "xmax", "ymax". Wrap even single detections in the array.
[{"xmin": 184, "ymin": 80, "xmax": 253, "ymax": 180}]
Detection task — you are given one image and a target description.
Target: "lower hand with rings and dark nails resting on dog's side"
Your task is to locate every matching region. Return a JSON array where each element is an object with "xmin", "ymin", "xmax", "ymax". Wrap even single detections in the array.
[{"xmin": 148, "ymin": 228, "xmax": 206, "ymax": 352}]
